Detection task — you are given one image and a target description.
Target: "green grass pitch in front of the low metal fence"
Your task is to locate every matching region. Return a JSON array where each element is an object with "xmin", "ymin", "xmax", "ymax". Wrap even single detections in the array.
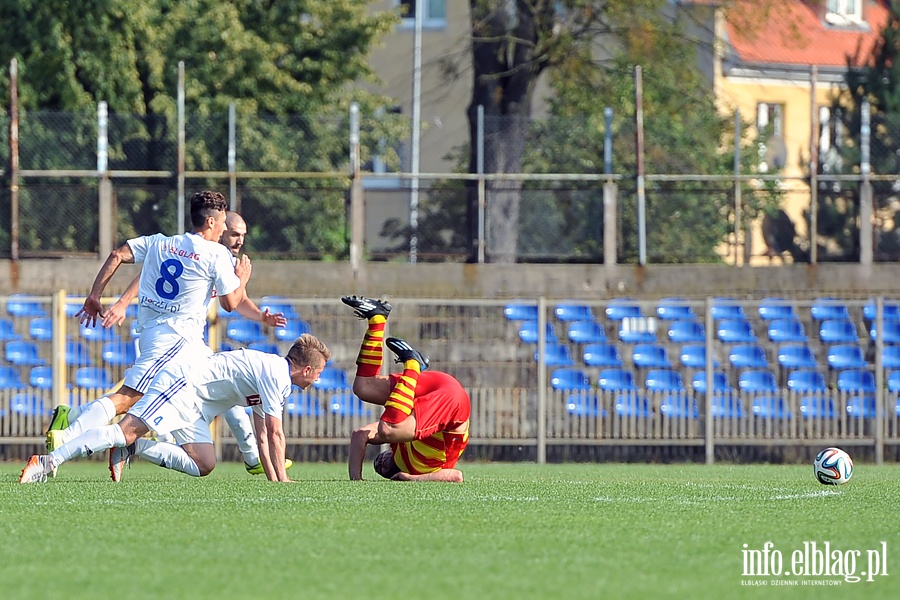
[{"xmin": 0, "ymin": 461, "xmax": 900, "ymax": 600}]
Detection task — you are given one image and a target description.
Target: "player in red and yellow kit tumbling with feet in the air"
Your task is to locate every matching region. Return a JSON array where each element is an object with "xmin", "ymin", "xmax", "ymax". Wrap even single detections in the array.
[{"xmin": 341, "ymin": 296, "xmax": 470, "ymax": 482}]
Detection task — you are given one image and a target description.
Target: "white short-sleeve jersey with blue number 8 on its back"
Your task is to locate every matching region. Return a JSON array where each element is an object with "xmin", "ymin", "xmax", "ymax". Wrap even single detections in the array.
[{"xmin": 127, "ymin": 233, "xmax": 241, "ymax": 340}]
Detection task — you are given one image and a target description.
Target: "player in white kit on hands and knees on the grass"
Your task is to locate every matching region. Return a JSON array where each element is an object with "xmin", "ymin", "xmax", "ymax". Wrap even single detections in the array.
[{"xmin": 19, "ymin": 333, "xmax": 331, "ymax": 483}]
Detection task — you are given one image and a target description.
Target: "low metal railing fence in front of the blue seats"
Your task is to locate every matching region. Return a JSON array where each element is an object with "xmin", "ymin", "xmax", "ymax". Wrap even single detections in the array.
[{"xmin": 0, "ymin": 293, "xmax": 900, "ymax": 462}]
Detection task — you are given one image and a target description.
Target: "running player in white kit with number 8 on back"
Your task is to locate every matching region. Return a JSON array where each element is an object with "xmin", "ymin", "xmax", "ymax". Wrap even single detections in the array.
[{"xmin": 41, "ymin": 190, "xmax": 274, "ymax": 474}]
